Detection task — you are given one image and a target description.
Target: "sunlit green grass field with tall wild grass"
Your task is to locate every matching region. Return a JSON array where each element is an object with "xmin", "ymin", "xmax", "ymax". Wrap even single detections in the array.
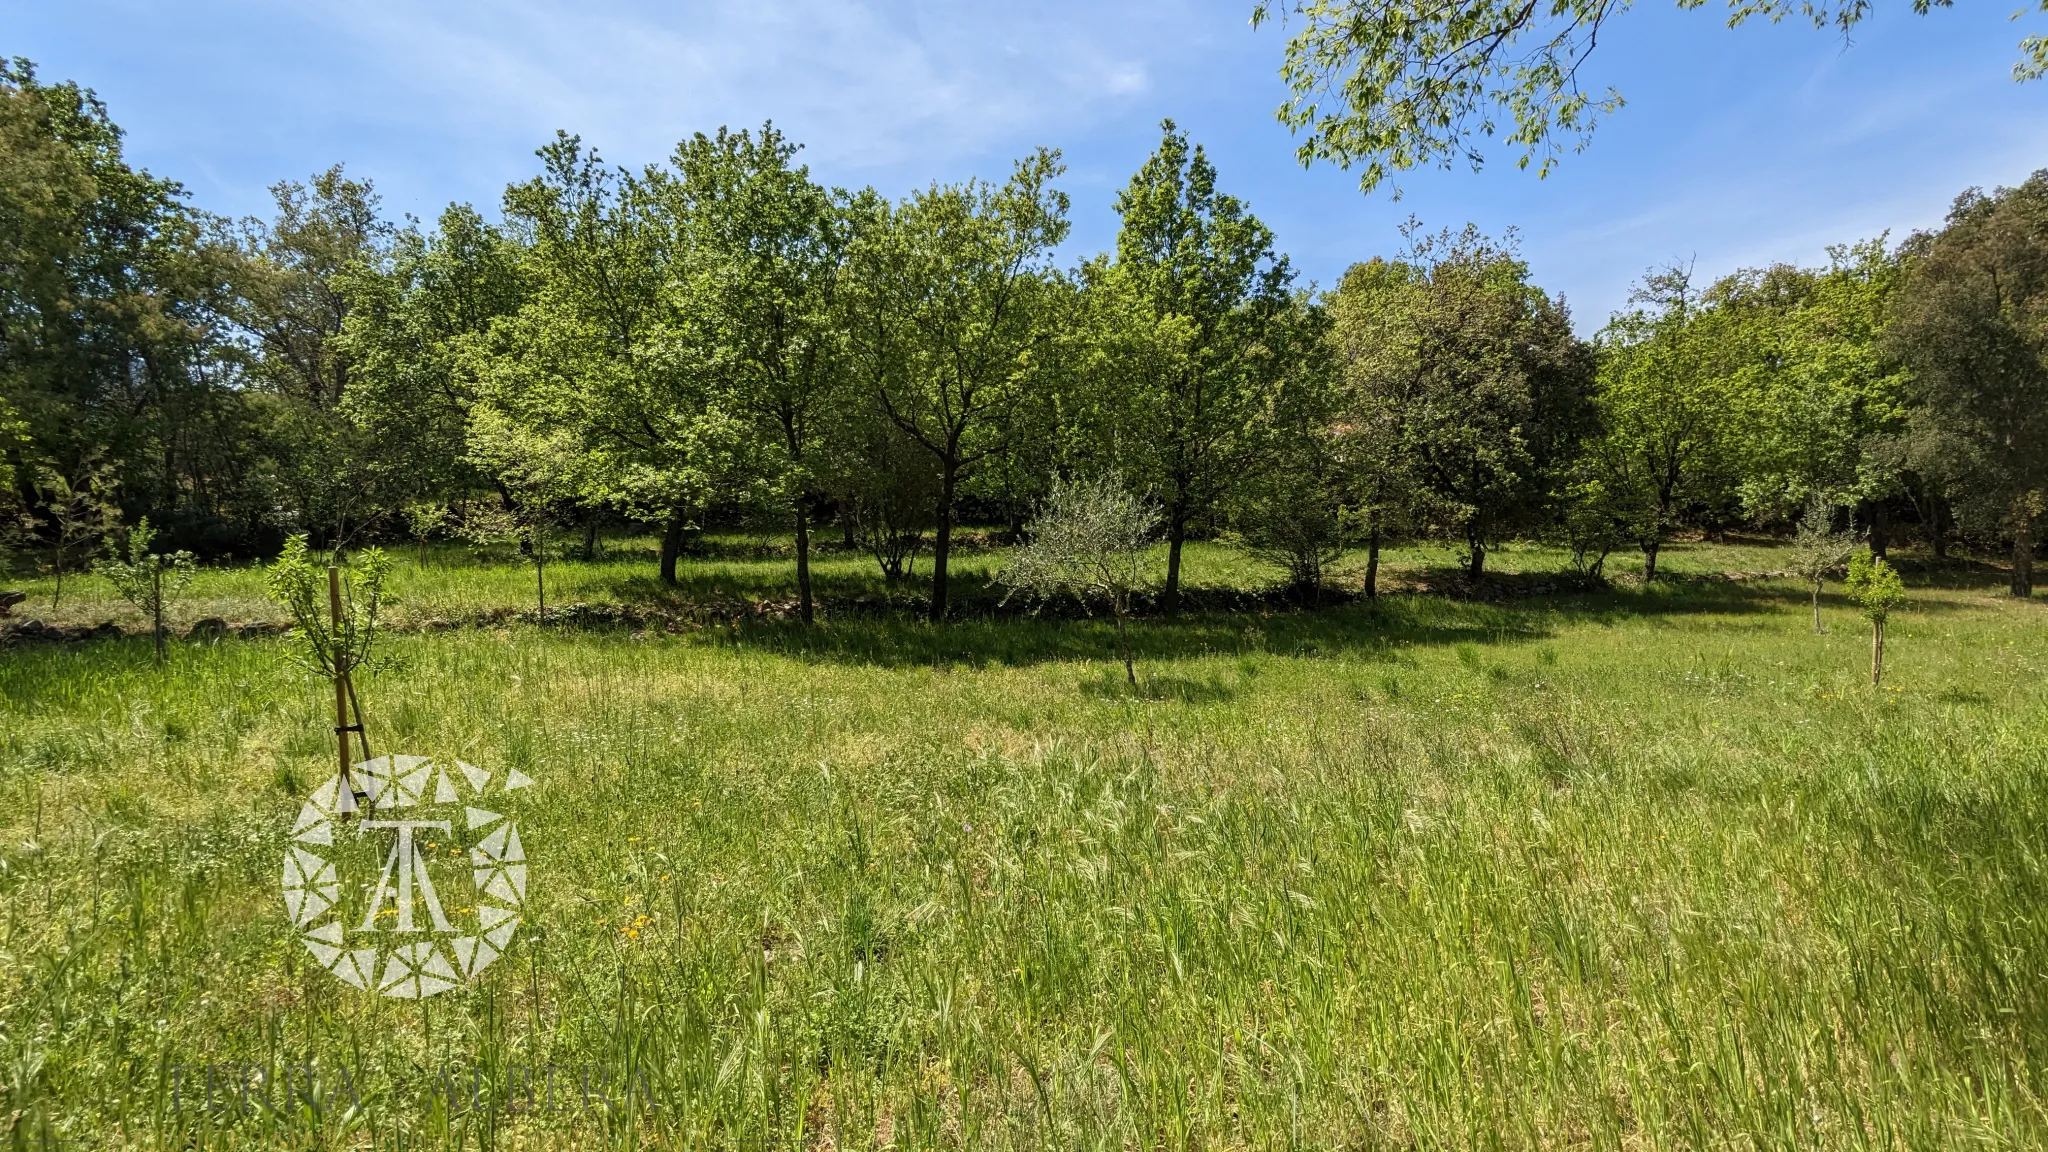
[{"xmin": 0, "ymin": 541, "xmax": 2048, "ymax": 1150}]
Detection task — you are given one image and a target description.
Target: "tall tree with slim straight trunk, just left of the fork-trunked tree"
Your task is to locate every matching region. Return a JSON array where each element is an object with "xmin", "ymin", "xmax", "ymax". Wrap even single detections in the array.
[{"xmin": 657, "ymin": 125, "xmax": 848, "ymax": 623}]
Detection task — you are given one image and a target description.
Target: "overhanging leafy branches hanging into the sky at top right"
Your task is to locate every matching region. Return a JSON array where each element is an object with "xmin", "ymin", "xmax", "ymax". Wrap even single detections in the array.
[{"xmin": 1251, "ymin": 0, "xmax": 2048, "ymax": 193}]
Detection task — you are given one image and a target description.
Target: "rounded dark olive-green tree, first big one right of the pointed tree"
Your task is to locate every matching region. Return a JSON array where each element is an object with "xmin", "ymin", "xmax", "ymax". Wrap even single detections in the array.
[{"xmin": 1333, "ymin": 223, "xmax": 1595, "ymax": 578}]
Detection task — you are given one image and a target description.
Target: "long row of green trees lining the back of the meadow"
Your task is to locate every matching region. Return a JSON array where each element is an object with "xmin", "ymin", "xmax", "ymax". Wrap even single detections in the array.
[{"xmin": 0, "ymin": 61, "xmax": 2048, "ymax": 617}]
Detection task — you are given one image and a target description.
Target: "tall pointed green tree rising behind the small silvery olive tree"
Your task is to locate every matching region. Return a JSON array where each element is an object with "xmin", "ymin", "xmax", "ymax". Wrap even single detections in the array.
[{"xmin": 1087, "ymin": 121, "xmax": 1292, "ymax": 613}]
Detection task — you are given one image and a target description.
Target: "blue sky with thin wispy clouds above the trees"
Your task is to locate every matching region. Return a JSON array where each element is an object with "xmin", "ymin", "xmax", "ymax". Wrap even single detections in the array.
[{"xmin": 0, "ymin": 0, "xmax": 2048, "ymax": 330}]
